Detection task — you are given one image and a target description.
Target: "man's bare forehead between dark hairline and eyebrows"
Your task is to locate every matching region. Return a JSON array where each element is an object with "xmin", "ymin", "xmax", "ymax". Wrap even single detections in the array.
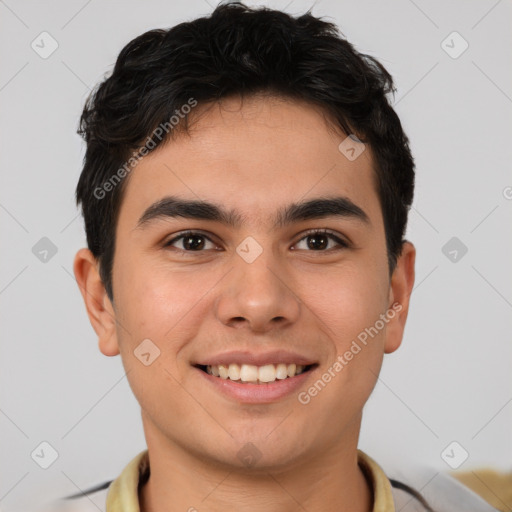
[{"xmin": 120, "ymin": 96, "xmax": 380, "ymax": 229}]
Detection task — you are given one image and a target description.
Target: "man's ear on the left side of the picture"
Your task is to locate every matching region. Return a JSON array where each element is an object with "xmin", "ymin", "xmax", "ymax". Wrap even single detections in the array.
[{"xmin": 73, "ymin": 249, "xmax": 119, "ymax": 356}]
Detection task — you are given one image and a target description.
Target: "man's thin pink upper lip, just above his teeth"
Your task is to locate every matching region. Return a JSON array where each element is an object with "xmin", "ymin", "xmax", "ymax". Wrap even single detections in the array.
[{"xmin": 195, "ymin": 349, "xmax": 315, "ymax": 366}]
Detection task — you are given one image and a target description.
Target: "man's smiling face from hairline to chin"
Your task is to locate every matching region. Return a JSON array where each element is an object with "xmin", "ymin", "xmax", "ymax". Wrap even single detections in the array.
[{"xmin": 75, "ymin": 97, "xmax": 414, "ymax": 468}]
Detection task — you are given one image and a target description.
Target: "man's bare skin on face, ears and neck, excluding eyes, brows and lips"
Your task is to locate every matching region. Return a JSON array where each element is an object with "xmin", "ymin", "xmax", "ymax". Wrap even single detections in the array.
[{"xmin": 74, "ymin": 96, "xmax": 415, "ymax": 512}]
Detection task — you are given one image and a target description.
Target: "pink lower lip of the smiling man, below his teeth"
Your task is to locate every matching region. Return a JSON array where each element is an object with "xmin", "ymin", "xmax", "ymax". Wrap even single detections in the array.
[{"xmin": 196, "ymin": 368, "xmax": 314, "ymax": 404}]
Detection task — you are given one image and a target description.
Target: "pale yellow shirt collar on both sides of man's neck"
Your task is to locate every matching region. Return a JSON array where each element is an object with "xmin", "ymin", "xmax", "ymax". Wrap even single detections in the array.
[{"xmin": 106, "ymin": 450, "xmax": 395, "ymax": 512}]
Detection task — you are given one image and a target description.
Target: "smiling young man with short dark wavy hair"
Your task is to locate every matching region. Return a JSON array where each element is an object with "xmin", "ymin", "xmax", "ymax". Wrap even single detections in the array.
[{"xmin": 53, "ymin": 4, "xmax": 492, "ymax": 512}]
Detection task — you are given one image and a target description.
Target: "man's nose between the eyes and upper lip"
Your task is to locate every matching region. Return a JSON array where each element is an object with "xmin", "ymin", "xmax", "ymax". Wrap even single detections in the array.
[{"xmin": 215, "ymin": 250, "xmax": 301, "ymax": 333}]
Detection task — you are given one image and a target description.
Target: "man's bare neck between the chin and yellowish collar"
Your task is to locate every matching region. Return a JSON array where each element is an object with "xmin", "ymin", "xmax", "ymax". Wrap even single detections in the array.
[{"xmin": 139, "ymin": 418, "xmax": 373, "ymax": 512}]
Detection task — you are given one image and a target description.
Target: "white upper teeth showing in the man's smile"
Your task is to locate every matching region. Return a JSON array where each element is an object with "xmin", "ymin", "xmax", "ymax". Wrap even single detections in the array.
[{"xmin": 206, "ymin": 363, "xmax": 305, "ymax": 382}]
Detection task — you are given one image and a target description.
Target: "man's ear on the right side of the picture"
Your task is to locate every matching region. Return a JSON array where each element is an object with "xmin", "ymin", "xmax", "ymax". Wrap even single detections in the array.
[{"xmin": 384, "ymin": 241, "xmax": 416, "ymax": 354}]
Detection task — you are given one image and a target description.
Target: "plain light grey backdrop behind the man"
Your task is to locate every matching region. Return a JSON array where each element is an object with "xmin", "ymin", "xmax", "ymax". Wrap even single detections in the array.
[{"xmin": 0, "ymin": 0, "xmax": 512, "ymax": 511}]
